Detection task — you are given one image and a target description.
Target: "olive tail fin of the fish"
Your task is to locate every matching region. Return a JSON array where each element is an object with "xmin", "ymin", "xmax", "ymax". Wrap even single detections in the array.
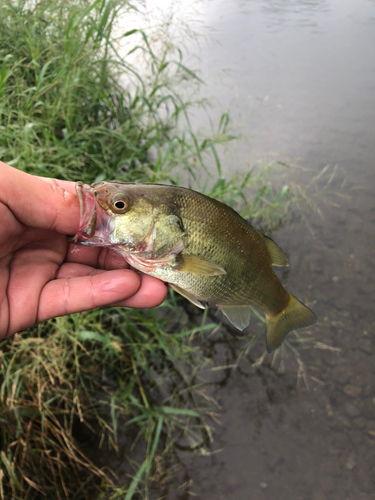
[{"xmin": 266, "ymin": 295, "xmax": 316, "ymax": 352}]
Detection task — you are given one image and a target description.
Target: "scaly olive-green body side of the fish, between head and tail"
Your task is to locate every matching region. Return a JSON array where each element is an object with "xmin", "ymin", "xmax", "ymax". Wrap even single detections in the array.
[{"xmin": 149, "ymin": 188, "xmax": 289, "ymax": 312}]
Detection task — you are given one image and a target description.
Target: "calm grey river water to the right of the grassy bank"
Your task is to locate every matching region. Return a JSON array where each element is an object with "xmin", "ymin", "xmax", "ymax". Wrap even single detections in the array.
[{"xmin": 156, "ymin": 0, "xmax": 375, "ymax": 500}]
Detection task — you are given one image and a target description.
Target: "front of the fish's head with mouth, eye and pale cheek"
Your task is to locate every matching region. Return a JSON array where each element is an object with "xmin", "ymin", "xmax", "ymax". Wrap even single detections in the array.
[{"xmin": 72, "ymin": 182, "xmax": 154, "ymax": 251}]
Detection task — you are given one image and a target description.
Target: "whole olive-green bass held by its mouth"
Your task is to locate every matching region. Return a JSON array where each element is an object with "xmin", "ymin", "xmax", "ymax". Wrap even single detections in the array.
[{"xmin": 72, "ymin": 181, "xmax": 316, "ymax": 352}]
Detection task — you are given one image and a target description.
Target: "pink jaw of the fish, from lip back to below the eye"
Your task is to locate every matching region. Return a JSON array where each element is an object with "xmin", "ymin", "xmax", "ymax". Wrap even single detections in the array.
[{"xmin": 71, "ymin": 182, "xmax": 113, "ymax": 246}]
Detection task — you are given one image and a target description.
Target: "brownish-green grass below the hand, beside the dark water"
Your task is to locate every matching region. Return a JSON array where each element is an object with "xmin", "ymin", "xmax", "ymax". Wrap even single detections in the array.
[{"xmin": 0, "ymin": 308, "xmax": 213, "ymax": 498}]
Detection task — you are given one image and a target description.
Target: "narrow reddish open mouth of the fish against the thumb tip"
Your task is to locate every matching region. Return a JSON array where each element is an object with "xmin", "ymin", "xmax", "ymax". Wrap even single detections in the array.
[{"xmin": 71, "ymin": 182, "xmax": 97, "ymax": 243}]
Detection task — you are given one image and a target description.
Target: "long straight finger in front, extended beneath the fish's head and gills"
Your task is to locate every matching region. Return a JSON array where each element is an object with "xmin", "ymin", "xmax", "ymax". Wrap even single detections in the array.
[{"xmin": 37, "ymin": 269, "xmax": 141, "ymax": 321}]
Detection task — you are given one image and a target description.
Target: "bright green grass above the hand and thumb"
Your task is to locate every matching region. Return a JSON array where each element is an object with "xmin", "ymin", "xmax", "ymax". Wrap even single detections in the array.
[{"xmin": 0, "ymin": 0, "xmax": 235, "ymax": 186}]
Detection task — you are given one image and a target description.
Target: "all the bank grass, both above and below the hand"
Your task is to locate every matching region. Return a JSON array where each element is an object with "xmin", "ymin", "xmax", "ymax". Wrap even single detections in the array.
[{"xmin": 0, "ymin": 0, "xmax": 300, "ymax": 500}]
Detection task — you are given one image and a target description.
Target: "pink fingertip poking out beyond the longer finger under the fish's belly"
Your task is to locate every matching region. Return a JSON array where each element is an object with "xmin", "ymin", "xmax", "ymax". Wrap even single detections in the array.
[{"xmin": 112, "ymin": 274, "xmax": 168, "ymax": 308}]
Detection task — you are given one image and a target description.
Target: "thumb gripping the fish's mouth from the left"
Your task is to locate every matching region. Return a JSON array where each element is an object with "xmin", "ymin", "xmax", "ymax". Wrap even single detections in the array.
[{"xmin": 0, "ymin": 162, "xmax": 79, "ymax": 234}]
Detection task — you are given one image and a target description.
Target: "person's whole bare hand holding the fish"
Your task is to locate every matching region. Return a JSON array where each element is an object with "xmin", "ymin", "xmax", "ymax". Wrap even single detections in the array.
[{"xmin": 0, "ymin": 162, "xmax": 167, "ymax": 339}]
